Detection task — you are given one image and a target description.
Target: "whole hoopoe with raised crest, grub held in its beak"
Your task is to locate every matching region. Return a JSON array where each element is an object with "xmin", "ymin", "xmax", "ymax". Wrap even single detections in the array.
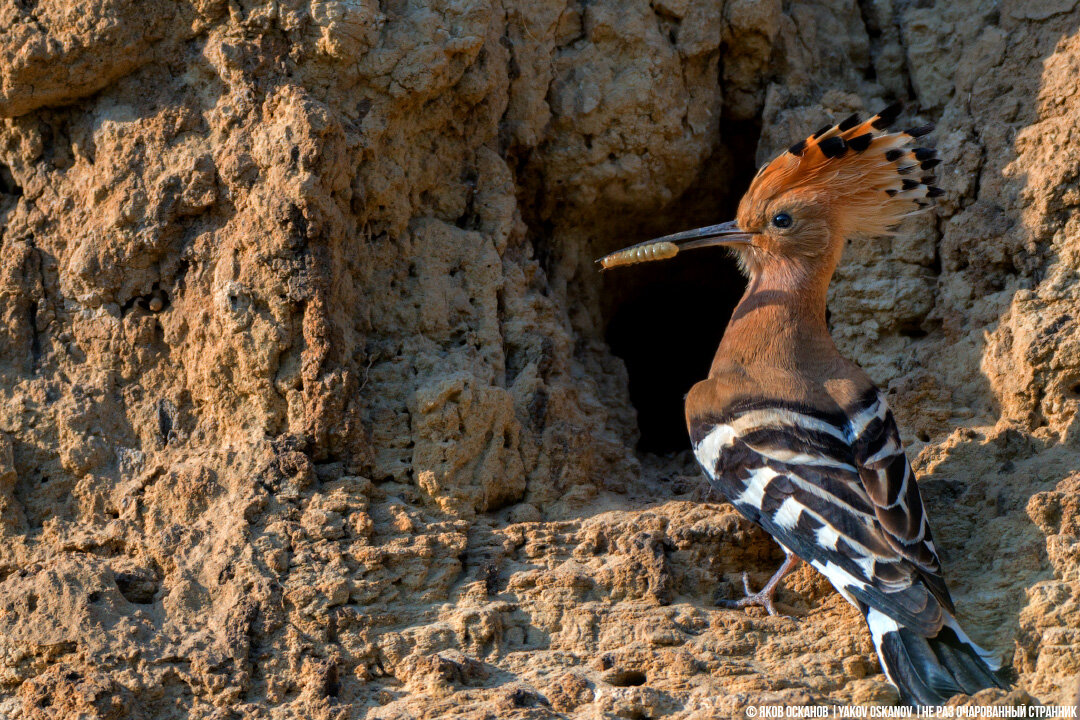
[{"xmin": 599, "ymin": 104, "xmax": 1002, "ymax": 706}]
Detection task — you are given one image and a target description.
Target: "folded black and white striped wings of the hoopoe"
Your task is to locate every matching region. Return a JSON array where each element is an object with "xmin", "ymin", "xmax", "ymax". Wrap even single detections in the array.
[{"xmin": 691, "ymin": 392, "xmax": 951, "ymax": 635}]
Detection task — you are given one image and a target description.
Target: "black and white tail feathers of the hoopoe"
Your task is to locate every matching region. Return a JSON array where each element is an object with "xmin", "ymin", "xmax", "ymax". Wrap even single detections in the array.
[{"xmin": 866, "ymin": 608, "xmax": 1002, "ymax": 705}]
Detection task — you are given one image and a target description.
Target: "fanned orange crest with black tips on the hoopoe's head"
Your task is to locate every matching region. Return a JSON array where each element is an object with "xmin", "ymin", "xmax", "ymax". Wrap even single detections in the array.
[{"xmin": 738, "ymin": 103, "xmax": 944, "ymax": 237}]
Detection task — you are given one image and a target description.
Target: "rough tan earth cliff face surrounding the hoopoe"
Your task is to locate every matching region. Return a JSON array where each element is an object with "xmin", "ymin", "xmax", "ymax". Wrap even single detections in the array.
[{"xmin": 0, "ymin": 0, "xmax": 1080, "ymax": 719}]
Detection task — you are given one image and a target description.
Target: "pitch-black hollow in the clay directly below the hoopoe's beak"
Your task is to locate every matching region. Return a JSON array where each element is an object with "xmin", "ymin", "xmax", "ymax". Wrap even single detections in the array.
[{"xmin": 605, "ymin": 250, "xmax": 745, "ymax": 454}]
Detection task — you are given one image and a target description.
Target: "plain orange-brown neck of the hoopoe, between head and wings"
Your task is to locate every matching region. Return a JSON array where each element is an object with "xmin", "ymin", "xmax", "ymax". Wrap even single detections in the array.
[{"xmin": 713, "ymin": 267, "xmax": 839, "ymax": 375}]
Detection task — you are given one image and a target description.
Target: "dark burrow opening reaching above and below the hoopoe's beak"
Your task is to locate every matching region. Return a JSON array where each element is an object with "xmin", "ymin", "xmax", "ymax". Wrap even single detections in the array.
[{"xmin": 600, "ymin": 122, "xmax": 760, "ymax": 454}]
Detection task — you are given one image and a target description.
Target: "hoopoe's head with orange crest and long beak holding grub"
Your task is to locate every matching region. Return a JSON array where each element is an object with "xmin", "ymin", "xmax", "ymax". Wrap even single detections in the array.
[{"xmin": 599, "ymin": 104, "xmax": 942, "ymax": 282}]
